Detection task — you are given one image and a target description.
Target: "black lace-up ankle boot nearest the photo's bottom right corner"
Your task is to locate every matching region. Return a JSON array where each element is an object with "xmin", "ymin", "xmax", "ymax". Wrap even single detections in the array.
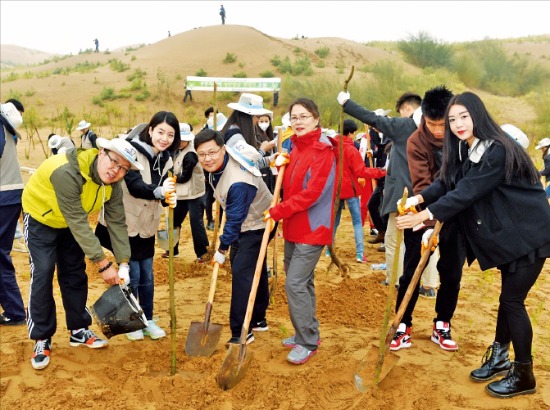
[{"xmin": 485, "ymin": 361, "xmax": 537, "ymax": 398}]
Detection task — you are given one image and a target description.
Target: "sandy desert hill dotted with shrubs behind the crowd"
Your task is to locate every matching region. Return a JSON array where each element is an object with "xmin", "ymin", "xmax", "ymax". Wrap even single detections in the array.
[{"xmin": 0, "ymin": 25, "xmax": 550, "ymax": 146}]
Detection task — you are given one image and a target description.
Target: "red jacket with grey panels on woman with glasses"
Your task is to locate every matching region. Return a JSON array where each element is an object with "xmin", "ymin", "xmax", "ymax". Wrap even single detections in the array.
[{"xmin": 269, "ymin": 128, "xmax": 336, "ymax": 245}]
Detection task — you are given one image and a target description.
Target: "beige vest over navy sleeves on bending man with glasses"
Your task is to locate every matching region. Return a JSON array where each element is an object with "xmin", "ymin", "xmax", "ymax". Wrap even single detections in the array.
[{"xmin": 214, "ymin": 156, "xmax": 273, "ymax": 232}]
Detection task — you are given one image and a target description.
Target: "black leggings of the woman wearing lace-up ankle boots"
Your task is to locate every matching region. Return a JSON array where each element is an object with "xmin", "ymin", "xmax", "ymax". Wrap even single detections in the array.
[{"xmin": 495, "ymin": 258, "xmax": 546, "ymax": 363}]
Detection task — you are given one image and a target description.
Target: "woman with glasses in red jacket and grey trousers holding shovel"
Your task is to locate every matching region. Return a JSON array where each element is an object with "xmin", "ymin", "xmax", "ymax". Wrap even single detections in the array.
[{"xmin": 269, "ymin": 98, "xmax": 336, "ymax": 364}]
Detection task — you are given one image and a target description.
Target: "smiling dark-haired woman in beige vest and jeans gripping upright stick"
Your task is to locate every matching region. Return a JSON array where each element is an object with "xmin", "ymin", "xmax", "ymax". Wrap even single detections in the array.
[{"xmin": 95, "ymin": 111, "xmax": 181, "ymax": 341}]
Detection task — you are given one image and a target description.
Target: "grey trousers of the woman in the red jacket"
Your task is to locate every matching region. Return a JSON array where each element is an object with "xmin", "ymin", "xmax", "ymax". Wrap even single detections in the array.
[{"xmin": 284, "ymin": 241, "xmax": 324, "ymax": 350}]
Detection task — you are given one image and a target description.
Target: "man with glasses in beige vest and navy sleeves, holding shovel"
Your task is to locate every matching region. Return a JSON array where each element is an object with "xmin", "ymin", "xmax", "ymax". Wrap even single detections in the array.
[{"xmin": 195, "ymin": 129, "xmax": 278, "ymax": 344}]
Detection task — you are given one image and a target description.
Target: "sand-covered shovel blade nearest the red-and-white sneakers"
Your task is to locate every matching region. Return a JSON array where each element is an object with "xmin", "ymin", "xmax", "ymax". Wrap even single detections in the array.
[{"xmin": 354, "ymin": 346, "xmax": 399, "ymax": 393}]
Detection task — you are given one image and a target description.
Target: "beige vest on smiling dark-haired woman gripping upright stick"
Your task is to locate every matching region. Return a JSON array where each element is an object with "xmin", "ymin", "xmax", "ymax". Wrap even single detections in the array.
[{"xmin": 122, "ymin": 151, "xmax": 172, "ymax": 238}]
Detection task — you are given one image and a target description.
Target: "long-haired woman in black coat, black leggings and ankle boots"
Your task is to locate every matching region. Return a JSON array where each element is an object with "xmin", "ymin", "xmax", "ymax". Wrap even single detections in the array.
[{"xmin": 396, "ymin": 92, "xmax": 550, "ymax": 397}]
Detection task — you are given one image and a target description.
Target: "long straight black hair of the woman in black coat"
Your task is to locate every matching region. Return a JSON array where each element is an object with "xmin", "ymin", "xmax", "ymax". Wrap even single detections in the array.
[{"xmin": 440, "ymin": 92, "xmax": 539, "ymax": 188}]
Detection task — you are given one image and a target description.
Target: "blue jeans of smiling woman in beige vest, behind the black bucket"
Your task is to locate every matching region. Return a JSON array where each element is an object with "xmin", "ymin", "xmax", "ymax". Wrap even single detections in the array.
[{"xmin": 129, "ymin": 258, "xmax": 155, "ymax": 320}]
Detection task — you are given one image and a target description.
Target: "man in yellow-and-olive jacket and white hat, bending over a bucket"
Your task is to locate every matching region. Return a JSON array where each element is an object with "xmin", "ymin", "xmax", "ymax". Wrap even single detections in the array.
[{"xmin": 23, "ymin": 138, "xmax": 143, "ymax": 370}]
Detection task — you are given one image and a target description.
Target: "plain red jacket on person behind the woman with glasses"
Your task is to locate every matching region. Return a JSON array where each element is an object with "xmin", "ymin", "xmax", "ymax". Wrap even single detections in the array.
[{"xmin": 331, "ymin": 135, "xmax": 386, "ymax": 199}]
